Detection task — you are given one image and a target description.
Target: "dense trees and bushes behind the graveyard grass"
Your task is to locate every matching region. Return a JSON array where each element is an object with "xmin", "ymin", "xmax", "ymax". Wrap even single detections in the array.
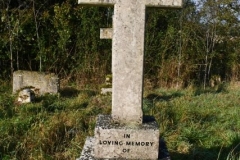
[{"xmin": 0, "ymin": 0, "xmax": 240, "ymax": 87}]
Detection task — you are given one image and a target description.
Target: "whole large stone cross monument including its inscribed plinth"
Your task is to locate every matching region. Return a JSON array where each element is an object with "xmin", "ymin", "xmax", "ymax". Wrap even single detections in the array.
[{"xmin": 78, "ymin": 0, "xmax": 182, "ymax": 160}]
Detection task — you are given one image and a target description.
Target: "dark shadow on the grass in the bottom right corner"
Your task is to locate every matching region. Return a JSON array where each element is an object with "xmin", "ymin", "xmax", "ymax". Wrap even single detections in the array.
[{"xmin": 168, "ymin": 137, "xmax": 240, "ymax": 160}]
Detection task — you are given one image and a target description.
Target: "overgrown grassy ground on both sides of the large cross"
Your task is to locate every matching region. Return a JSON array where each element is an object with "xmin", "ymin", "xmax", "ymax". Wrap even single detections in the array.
[{"xmin": 0, "ymin": 81, "xmax": 240, "ymax": 160}]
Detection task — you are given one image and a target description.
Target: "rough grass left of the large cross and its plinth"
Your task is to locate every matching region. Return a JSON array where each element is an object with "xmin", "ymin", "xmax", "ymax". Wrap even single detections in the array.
[{"xmin": 0, "ymin": 83, "xmax": 111, "ymax": 159}]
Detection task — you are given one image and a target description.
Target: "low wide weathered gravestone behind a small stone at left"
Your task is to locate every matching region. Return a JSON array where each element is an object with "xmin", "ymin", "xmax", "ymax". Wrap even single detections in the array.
[{"xmin": 13, "ymin": 70, "xmax": 59, "ymax": 95}]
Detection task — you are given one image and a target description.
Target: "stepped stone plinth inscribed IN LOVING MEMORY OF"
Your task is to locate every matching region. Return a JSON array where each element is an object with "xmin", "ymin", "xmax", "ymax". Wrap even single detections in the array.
[{"xmin": 79, "ymin": 115, "xmax": 159, "ymax": 160}]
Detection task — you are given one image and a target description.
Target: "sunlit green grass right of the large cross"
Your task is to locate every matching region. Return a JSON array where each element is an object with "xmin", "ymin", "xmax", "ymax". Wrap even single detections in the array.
[{"xmin": 143, "ymin": 84, "xmax": 240, "ymax": 160}]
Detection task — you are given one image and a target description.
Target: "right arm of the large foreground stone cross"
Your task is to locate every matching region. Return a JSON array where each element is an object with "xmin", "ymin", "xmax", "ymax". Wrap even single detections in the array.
[{"xmin": 145, "ymin": 0, "xmax": 182, "ymax": 8}]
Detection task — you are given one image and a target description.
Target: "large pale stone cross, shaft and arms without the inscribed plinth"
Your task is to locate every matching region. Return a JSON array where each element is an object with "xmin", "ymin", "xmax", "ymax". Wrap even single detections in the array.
[{"xmin": 78, "ymin": 0, "xmax": 182, "ymax": 125}]
